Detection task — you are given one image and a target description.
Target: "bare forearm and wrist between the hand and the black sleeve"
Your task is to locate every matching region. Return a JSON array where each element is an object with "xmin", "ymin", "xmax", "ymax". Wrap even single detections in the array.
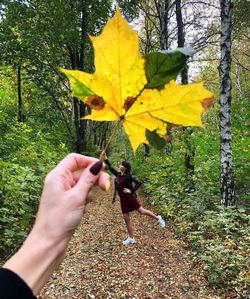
[{"xmin": 3, "ymin": 228, "xmax": 69, "ymax": 295}]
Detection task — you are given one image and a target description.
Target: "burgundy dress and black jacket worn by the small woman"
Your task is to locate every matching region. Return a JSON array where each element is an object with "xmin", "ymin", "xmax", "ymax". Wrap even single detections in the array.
[{"xmin": 105, "ymin": 159, "xmax": 141, "ymax": 214}]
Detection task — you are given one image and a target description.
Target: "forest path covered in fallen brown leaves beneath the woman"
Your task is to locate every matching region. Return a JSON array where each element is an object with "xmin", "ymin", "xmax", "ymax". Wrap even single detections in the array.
[{"xmin": 39, "ymin": 189, "xmax": 209, "ymax": 299}]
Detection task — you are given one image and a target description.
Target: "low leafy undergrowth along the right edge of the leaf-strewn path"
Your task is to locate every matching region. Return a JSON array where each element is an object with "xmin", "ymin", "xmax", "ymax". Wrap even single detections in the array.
[{"xmin": 133, "ymin": 124, "xmax": 250, "ymax": 298}]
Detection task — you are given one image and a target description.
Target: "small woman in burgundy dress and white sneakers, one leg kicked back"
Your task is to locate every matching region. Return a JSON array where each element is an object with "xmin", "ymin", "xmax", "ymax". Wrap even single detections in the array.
[{"xmin": 104, "ymin": 155, "xmax": 165, "ymax": 245}]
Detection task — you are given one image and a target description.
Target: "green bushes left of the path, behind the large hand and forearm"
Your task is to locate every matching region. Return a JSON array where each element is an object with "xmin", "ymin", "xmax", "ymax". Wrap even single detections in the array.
[{"xmin": 0, "ymin": 69, "xmax": 68, "ymax": 260}]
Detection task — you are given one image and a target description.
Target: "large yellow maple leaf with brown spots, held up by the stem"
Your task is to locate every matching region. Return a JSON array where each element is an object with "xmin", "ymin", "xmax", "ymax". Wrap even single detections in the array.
[{"xmin": 63, "ymin": 9, "xmax": 213, "ymax": 152}]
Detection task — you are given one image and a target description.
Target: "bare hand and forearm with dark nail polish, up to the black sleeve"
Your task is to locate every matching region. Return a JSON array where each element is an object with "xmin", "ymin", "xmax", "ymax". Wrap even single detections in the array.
[{"xmin": 3, "ymin": 154, "xmax": 110, "ymax": 295}]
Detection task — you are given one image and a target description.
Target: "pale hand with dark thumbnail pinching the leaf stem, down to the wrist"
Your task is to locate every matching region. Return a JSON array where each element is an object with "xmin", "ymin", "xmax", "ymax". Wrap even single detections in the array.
[{"xmin": 34, "ymin": 154, "xmax": 109, "ymax": 241}]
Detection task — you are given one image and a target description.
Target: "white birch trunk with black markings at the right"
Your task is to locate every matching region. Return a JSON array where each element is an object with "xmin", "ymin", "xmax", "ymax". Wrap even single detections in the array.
[{"xmin": 219, "ymin": 0, "xmax": 235, "ymax": 206}]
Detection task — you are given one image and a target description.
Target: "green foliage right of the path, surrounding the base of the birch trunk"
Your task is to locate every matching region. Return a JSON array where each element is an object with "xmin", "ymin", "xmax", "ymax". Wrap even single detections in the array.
[{"xmin": 132, "ymin": 98, "xmax": 250, "ymax": 294}]
